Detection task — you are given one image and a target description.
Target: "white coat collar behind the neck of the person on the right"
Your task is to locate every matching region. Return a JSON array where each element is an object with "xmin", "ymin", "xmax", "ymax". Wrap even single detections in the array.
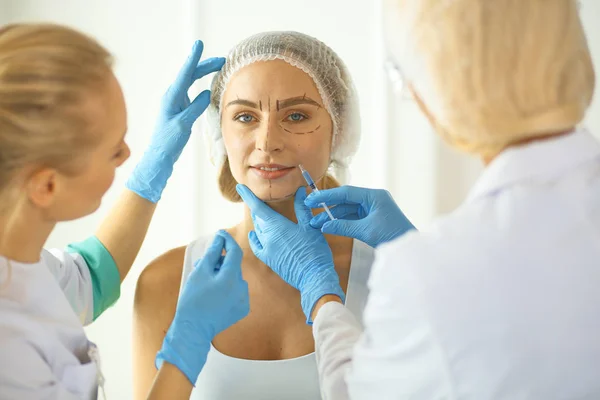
[{"xmin": 467, "ymin": 129, "xmax": 600, "ymax": 202}]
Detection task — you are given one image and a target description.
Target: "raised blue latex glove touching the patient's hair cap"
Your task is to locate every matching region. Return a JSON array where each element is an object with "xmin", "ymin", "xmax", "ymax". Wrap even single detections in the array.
[{"xmin": 126, "ymin": 41, "xmax": 225, "ymax": 203}]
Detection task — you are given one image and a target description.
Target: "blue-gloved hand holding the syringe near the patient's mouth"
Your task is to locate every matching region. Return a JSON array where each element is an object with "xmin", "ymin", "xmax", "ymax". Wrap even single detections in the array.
[{"xmin": 305, "ymin": 186, "xmax": 415, "ymax": 247}]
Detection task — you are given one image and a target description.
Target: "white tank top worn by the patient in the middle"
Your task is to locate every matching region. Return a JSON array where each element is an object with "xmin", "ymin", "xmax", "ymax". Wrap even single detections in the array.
[{"xmin": 181, "ymin": 237, "xmax": 374, "ymax": 400}]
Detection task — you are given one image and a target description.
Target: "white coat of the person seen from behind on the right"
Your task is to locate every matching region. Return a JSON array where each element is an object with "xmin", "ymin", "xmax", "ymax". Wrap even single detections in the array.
[{"xmin": 313, "ymin": 130, "xmax": 600, "ymax": 400}]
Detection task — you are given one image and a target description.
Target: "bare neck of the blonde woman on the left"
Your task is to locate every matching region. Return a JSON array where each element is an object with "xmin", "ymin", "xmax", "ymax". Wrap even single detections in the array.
[{"xmin": 0, "ymin": 205, "xmax": 56, "ymax": 263}]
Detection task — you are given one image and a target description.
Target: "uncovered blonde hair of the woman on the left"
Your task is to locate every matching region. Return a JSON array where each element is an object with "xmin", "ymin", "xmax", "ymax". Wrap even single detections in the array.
[{"xmin": 0, "ymin": 24, "xmax": 112, "ymax": 198}]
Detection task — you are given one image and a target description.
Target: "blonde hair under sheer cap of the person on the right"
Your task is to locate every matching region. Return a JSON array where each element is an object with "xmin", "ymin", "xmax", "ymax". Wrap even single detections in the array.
[{"xmin": 385, "ymin": 0, "xmax": 595, "ymax": 155}]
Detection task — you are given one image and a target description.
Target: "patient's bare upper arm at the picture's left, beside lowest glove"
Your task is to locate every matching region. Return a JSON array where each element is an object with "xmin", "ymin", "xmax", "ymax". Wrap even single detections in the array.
[{"xmin": 133, "ymin": 247, "xmax": 184, "ymax": 400}]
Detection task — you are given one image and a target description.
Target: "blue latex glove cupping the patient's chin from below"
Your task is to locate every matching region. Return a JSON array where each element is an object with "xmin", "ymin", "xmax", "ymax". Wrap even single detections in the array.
[{"xmin": 237, "ymin": 185, "xmax": 344, "ymax": 324}]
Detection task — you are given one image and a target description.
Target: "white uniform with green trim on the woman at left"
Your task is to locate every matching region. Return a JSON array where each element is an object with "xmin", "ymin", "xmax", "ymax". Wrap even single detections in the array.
[{"xmin": 0, "ymin": 242, "xmax": 120, "ymax": 400}]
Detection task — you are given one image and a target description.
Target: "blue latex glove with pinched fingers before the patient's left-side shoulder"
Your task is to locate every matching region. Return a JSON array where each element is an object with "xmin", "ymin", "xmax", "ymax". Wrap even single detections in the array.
[{"xmin": 155, "ymin": 231, "xmax": 250, "ymax": 385}]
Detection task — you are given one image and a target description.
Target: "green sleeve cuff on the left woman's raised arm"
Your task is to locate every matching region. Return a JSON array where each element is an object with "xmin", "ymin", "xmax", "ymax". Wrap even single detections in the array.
[{"xmin": 67, "ymin": 236, "xmax": 121, "ymax": 320}]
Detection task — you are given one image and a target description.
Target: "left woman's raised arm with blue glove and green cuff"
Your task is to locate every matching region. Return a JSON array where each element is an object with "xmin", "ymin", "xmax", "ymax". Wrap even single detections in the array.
[{"xmin": 63, "ymin": 41, "xmax": 225, "ymax": 318}]
